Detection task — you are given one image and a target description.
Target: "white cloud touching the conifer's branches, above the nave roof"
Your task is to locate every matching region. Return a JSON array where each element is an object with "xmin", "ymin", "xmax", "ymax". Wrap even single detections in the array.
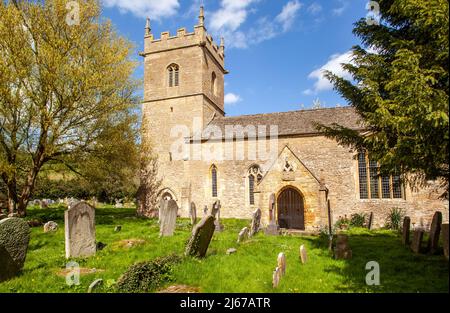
[{"xmin": 303, "ymin": 51, "xmax": 353, "ymax": 95}]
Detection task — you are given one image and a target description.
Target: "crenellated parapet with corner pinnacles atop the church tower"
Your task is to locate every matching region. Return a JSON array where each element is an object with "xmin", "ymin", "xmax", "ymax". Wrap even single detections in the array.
[{"xmin": 141, "ymin": 7, "xmax": 226, "ymax": 72}]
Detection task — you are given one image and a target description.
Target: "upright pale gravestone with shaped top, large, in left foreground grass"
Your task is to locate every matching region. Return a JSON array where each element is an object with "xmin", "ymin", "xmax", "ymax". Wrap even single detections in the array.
[{"xmin": 64, "ymin": 202, "xmax": 96, "ymax": 259}]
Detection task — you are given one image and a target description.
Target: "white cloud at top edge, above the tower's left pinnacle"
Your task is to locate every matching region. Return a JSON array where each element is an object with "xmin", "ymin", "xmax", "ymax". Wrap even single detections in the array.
[{"xmin": 102, "ymin": 0, "xmax": 180, "ymax": 20}]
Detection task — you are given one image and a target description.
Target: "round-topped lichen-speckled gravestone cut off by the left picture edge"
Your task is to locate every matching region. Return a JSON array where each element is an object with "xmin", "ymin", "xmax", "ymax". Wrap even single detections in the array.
[{"xmin": 0, "ymin": 218, "xmax": 30, "ymax": 282}]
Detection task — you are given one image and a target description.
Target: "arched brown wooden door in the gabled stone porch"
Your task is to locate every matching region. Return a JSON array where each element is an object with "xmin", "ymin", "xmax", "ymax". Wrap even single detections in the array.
[{"xmin": 277, "ymin": 187, "xmax": 305, "ymax": 230}]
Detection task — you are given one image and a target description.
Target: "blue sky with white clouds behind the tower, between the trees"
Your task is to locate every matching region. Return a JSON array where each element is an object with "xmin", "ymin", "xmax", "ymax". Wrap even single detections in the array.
[{"xmin": 102, "ymin": 0, "xmax": 367, "ymax": 116}]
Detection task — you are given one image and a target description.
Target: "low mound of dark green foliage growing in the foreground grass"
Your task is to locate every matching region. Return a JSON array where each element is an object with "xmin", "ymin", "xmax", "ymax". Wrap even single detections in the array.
[{"xmin": 117, "ymin": 254, "xmax": 181, "ymax": 293}]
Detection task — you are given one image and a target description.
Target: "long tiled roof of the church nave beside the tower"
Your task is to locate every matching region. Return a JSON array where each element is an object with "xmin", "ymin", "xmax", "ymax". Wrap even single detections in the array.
[{"xmin": 195, "ymin": 107, "xmax": 363, "ymax": 139}]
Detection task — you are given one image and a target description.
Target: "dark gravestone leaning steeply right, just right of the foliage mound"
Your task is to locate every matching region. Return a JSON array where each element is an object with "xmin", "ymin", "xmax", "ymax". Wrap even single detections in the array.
[{"xmin": 185, "ymin": 215, "xmax": 215, "ymax": 258}]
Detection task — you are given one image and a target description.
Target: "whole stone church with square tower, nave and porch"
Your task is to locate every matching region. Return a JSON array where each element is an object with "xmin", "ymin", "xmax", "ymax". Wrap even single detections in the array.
[{"xmin": 141, "ymin": 9, "xmax": 448, "ymax": 230}]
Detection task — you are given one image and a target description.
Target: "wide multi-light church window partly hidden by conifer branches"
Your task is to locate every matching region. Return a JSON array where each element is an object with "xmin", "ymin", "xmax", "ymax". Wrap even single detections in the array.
[{"xmin": 358, "ymin": 152, "xmax": 403, "ymax": 199}]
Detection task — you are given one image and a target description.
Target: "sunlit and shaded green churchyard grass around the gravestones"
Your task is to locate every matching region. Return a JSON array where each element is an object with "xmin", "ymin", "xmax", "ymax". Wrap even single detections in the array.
[{"xmin": 0, "ymin": 207, "xmax": 449, "ymax": 293}]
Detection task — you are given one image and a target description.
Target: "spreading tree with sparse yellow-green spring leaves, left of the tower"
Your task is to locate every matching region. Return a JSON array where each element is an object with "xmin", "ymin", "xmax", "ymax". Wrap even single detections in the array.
[{"xmin": 0, "ymin": 0, "xmax": 136, "ymax": 216}]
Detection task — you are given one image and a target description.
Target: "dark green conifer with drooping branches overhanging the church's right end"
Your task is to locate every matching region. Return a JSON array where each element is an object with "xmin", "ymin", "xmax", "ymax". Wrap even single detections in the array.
[{"xmin": 318, "ymin": 0, "xmax": 449, "ymax": 192}]
